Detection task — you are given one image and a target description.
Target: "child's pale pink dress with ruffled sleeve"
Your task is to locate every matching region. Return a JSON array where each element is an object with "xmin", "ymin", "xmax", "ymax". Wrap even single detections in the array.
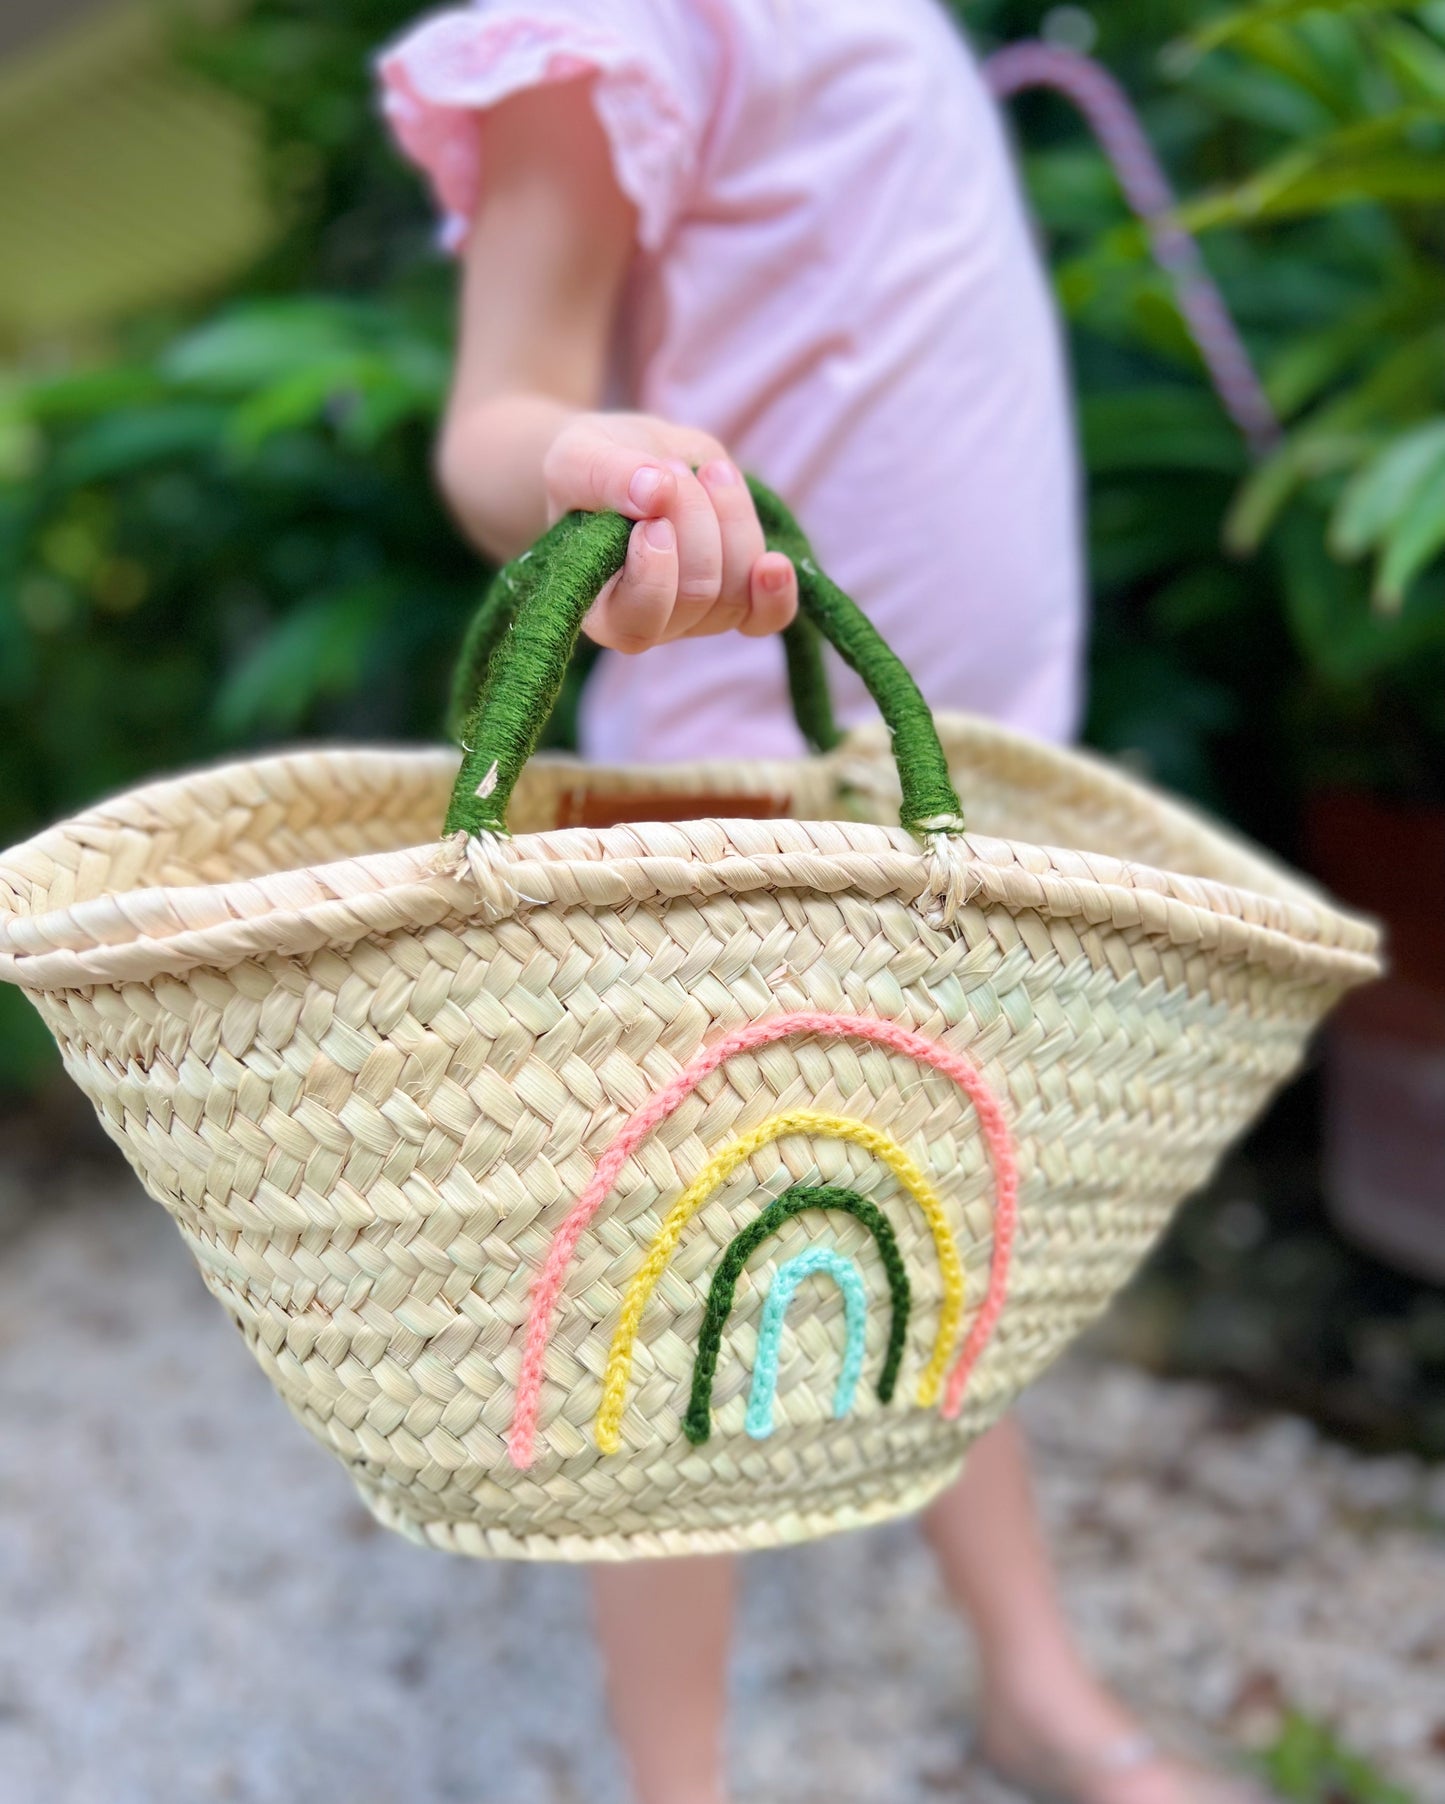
[{"xmin": 379, "ymin": 0, "xmax": 1084, "ymax": 761}]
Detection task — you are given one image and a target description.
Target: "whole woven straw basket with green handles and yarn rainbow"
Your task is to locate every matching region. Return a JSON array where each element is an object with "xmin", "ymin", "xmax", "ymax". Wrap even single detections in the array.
[{"xmin": 0, "ymin": 489, "xmax": 1376, "ymax": 1559}]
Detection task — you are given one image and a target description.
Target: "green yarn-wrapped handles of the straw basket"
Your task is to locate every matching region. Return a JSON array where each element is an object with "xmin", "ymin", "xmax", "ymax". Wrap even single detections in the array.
[{"xmin": 444, "ymin": 478, "xmax": 963, "ymax": 835}]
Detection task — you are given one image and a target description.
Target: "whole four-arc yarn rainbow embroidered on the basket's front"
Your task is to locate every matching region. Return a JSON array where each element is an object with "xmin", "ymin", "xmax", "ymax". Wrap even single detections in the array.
[{"xmin": 507, "ymin": 1012, "xmax": 1017, "ymax": 1468}]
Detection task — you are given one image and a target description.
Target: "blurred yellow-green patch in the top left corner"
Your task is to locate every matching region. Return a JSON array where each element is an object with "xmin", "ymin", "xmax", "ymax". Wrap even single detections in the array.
[{"xmin": 0, "ymin": 0, "xmax": 269, "ymax": 354}]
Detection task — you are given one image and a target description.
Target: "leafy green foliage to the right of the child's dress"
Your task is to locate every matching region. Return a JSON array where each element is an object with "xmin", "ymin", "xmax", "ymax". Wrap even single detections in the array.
[{"xmin": 960, "ymin": 0, "xmax": 1445, "ymax": 819}]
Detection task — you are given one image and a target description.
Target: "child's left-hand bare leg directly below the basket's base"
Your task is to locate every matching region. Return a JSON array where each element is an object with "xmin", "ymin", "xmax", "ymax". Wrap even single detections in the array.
[{"xmin": 594, "ymin": 1559, "xmax": 736, "ymax": 1804}]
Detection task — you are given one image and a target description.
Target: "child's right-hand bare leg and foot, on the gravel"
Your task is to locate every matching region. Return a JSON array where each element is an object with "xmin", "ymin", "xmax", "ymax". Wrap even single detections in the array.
[{"xmin": 924, "ymin": 1418, "xmax": 1257, "ymax": 1804}]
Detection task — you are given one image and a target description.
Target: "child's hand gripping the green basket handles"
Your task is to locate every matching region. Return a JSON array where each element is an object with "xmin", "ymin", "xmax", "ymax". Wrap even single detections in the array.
[{"xmin": 543, "ymin": 413, "xmax": 797, "ymax": 651}]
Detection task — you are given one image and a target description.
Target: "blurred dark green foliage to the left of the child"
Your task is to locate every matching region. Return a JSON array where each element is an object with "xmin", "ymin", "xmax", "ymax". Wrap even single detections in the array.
[{"xmin": 0, "ymin": 0, "xmax": 472, "ymax": 1091}]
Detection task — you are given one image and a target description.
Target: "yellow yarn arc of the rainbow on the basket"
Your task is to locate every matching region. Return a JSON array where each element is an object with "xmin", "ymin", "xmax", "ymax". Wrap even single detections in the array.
[{"xmin": 594, "ymin": 1109, "xmax": 963, "ymax": 1454}]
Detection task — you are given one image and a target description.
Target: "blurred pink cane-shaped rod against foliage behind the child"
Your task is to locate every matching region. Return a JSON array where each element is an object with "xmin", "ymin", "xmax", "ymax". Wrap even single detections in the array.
[{"xmin": 983, "ymin": 41, "xmax": 1279, "ymax": 456}]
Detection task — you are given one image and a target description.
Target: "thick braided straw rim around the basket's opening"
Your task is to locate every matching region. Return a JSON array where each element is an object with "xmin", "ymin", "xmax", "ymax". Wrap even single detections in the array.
[{"xmin": 0, "ymin": 722, "xmax": 1380, "ymax": 990}]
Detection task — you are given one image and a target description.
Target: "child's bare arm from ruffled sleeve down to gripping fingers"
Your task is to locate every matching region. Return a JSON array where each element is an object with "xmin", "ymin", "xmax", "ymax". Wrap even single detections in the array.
[{"xmin": 438, "ymin": 81, "xmax": 797, "ymax": 651}]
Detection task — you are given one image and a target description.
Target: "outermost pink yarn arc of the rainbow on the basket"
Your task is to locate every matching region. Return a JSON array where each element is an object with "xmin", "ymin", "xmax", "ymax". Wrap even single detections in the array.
[{"xmin": 507, "ymin": 1010, "xmax": 1019, "ymax": 1470}]
